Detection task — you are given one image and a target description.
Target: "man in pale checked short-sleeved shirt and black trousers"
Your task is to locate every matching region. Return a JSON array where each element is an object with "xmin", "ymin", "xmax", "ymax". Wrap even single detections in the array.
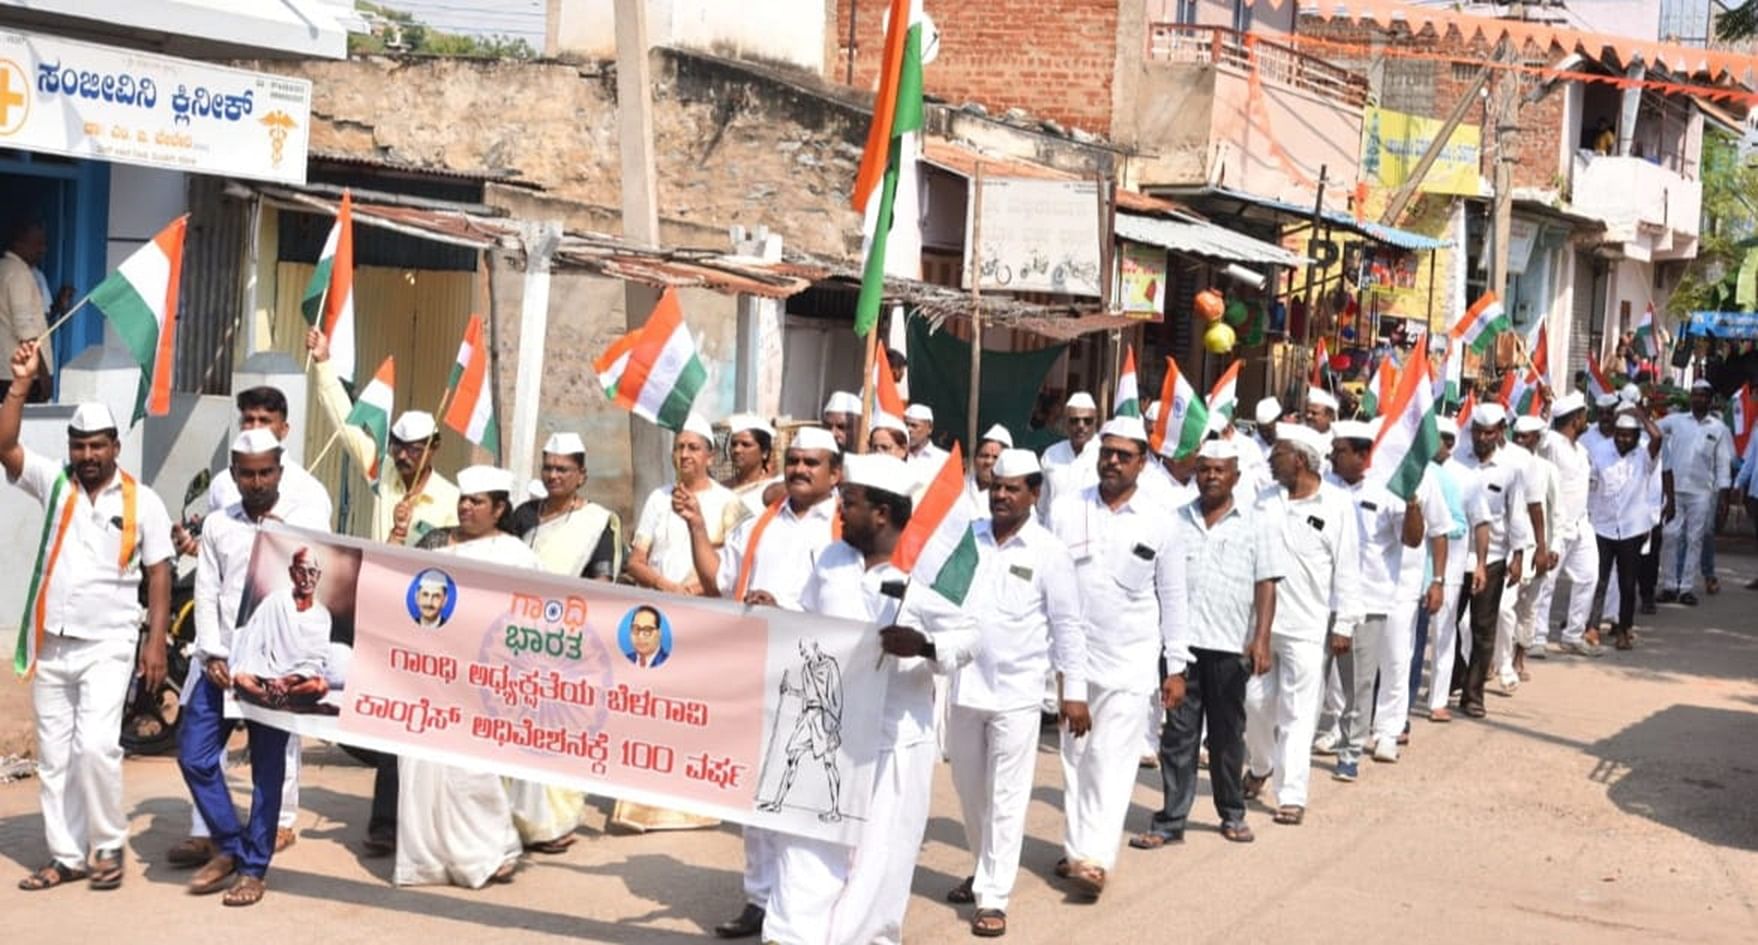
[{"xmin": 1130, "ymin": 439, "xmax": 1283, "ymax": 850}]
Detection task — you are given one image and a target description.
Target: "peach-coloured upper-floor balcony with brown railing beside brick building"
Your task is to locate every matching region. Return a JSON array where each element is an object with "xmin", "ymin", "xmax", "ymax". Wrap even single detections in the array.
[{"xmin": 1113, "ymin": 23, "xmax": 1368, "ymax": 204}]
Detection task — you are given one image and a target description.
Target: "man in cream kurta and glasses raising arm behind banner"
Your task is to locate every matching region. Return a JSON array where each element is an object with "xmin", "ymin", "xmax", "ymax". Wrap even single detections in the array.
[{"xmin": 306, "ymin": 328, "xmax": 457, "ymax": 545}]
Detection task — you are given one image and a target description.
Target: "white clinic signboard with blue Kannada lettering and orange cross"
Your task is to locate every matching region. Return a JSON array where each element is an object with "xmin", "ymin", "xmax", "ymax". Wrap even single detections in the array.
[{"xmin": 0, "ymin": 30, "xmax": 311, "ymax": 184}]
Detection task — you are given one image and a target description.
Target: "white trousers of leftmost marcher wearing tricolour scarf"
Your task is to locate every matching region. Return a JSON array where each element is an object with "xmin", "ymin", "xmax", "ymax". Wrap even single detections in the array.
[{"xmin": 32, "ymin": 629, "xmax": 135, "ymax": 869}]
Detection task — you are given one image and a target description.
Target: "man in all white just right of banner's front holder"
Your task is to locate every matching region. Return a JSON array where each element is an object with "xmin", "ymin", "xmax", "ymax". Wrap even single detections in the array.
[{"xmin": 946, "ymin": 450, "xmax": 1090, "ymax": 934}]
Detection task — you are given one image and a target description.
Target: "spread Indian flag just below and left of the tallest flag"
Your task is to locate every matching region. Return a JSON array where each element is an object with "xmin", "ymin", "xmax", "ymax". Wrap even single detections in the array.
[{"xmin": 592, "ymin": 288, "xmax": 708, "ymax": 432}]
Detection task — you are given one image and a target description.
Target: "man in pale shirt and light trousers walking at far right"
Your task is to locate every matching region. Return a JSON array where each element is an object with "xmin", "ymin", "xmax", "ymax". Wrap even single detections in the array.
[{"xmin": 1660, "ymin": 379, "xmax": 1733, "ymax": 606}]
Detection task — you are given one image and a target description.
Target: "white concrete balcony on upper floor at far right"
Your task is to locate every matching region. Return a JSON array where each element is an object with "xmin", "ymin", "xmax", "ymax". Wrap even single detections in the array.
[{"xmin": 1570, "ymin": 151, "xmax": 1704, "ymax": 262}]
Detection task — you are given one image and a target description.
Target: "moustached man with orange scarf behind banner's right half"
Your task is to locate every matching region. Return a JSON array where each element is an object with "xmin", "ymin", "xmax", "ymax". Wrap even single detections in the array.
[{"xmin": 684, "ymin": 427, "xmax": 842, "ymax": 938}]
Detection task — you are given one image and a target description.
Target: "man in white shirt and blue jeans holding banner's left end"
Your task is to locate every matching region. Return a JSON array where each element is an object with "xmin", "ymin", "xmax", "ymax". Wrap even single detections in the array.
[{"xmin": 178, "ymin": 427, "xmax": 329, "ymax": 906}]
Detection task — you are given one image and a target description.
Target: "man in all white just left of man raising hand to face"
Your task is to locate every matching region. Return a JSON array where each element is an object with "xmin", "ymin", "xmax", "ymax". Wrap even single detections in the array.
[{"xmin": 1529, "ymin": 393, "xmax": 1600, "ymax": 657}]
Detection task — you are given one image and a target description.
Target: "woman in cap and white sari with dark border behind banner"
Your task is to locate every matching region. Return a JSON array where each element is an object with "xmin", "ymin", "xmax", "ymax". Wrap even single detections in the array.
[{"xmin": 513, "ymin": 432, "xmax": 622, "ymax": 581}]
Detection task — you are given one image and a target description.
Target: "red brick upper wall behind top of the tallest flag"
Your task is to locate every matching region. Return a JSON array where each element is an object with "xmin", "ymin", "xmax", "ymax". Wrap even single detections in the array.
[{"xmin": 828, "ymin": 0, "xmax": 1118, "ymax": 133}]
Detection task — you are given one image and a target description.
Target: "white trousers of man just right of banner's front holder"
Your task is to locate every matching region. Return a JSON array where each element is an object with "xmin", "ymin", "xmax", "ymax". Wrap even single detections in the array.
[{"xmin": 949, "ymin": 706, "xmax": 1039, "ymax": 912}]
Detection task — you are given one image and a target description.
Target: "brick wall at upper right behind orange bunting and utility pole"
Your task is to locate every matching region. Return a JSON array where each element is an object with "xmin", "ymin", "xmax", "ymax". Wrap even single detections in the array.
[{"xmin": 1299, "ymin": 16, "xmax": 1566, "ymax": 190}]
